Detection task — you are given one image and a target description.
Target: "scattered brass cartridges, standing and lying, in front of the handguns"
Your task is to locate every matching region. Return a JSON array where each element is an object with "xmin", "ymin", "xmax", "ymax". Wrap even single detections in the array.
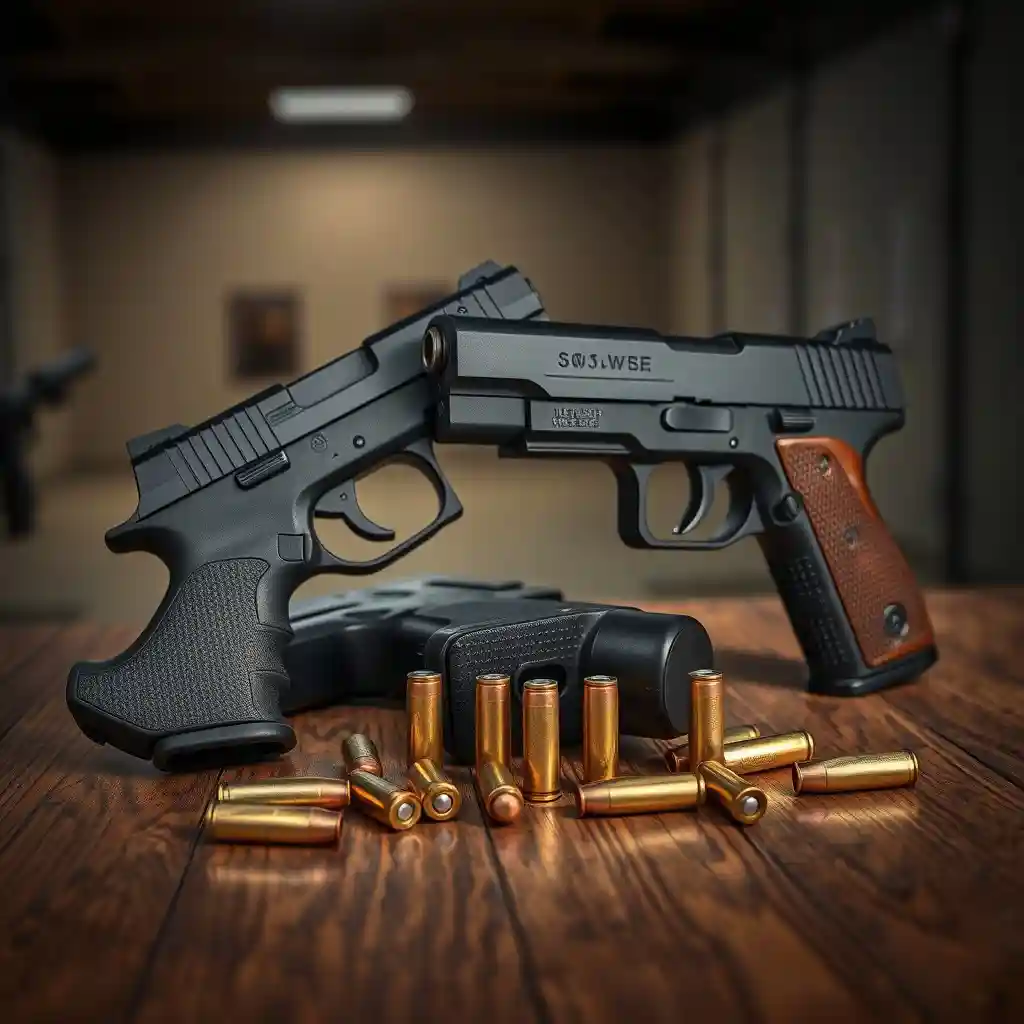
[{"xmin": 206, "ymin": 669, "xmax": 919, "ymax": 845}]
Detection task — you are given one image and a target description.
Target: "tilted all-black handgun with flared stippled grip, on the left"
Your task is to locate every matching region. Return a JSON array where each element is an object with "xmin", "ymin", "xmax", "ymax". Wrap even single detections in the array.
[{"xmin": 68, "ymin": 262, "xmax": 545, "ymax": 769}]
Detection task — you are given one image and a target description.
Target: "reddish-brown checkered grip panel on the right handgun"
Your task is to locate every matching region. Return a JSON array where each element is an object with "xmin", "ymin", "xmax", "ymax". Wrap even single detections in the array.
[{"xmin": 776, "ymin": 437, "xmax": 934, "ymax": 668}]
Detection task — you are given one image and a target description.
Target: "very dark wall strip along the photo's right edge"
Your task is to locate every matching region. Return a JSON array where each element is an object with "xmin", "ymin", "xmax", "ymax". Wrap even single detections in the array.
[{"xmin": 954, "ymin": 0, "xmax": 1024, "ymax": 582}]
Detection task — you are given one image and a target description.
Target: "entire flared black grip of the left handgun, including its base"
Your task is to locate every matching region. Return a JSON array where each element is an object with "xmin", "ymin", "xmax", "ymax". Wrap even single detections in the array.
[{"xmin": 68, "ymin": 558, "xmax": 295, "ymax": 771}]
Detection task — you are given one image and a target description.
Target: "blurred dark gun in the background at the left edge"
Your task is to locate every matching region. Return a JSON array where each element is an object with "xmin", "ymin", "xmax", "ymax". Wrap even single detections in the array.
[{"xmin": 0, "ymin": 348, "xmax": 95, "ymax": 537}]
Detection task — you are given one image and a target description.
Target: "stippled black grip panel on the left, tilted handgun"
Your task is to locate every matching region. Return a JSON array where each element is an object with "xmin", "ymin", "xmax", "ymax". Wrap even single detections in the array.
[{"xmin": 69, "ymin": 558, "xmax": 291, "ymax": 735}]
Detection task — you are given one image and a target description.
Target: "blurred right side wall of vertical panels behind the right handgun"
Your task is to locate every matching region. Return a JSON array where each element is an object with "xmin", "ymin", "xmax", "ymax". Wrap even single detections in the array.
[{"xmin": 671, "ymin": 8, "xmax": 947, "ymax": 572}]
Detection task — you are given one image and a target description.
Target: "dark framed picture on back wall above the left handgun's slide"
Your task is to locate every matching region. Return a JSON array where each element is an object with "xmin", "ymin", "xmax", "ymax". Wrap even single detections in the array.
[{"xmin": 227, "ymin": 289, "xmax": 301, "ymax": 381}]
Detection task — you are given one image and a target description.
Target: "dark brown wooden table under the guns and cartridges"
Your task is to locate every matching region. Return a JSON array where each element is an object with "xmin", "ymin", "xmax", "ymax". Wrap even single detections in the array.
[{"xmin": 0, "ymin": 591, "xmax": 1024, "ymax": 1024}]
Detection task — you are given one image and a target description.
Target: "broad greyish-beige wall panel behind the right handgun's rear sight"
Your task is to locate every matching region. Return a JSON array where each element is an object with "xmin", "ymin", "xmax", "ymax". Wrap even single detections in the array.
[{"xmin": 807, "ymin": 13, "xmax": 947, "ymax": 557}]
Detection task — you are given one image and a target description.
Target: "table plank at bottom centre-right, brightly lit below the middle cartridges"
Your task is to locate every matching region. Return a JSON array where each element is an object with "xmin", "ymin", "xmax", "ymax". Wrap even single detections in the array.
[{"xmin": 475, "ymin": 744, "xmax": 876, "ymax": 1024}]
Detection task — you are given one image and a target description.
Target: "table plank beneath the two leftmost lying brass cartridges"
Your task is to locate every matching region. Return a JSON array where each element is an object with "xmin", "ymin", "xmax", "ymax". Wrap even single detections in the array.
[{"xmin": 133, "ymin": 709, "xmax": 540, "ymax": 1024}]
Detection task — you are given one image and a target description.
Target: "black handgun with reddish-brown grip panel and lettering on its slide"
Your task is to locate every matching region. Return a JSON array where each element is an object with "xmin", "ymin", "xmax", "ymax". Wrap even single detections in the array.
[{"xmin": 423, "ymin": 316, "xmax": 937, "ymax": 694}]
